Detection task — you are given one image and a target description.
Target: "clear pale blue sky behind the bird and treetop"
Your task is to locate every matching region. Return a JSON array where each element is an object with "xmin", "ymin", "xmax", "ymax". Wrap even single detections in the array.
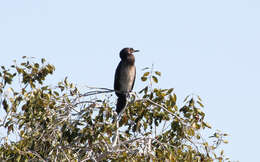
[{"xmin": 0, "ymin": 0, "xmax": 260, "ymax": 162}]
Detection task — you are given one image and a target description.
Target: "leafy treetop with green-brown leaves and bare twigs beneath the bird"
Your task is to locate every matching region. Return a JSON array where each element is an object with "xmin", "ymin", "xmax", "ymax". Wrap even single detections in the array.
[{"xmin": 0, "ymin": 57, "xmax": 228, "ymax": 161}]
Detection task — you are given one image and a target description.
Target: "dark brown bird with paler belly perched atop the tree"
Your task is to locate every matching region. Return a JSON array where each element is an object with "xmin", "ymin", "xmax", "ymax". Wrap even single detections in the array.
[{"xmin": 114, "ymin": 48, "xmax": 139, "ymax": 114}]
